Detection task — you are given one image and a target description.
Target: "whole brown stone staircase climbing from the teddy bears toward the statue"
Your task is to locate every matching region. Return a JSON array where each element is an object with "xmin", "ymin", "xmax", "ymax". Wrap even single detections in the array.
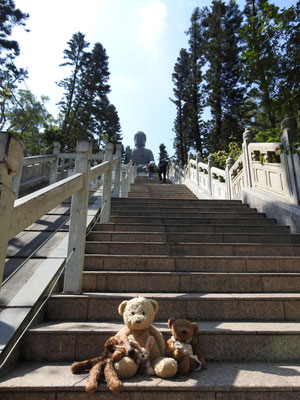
[{"xmin": 0, "ymin": 177, "xmax": 300, "ymax": 400}]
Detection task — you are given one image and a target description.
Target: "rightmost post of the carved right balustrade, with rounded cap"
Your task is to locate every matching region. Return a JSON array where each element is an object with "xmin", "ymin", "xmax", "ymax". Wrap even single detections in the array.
[{"xmin": 280, "ymin": 116, "xmax": 300, "ymax": 204}]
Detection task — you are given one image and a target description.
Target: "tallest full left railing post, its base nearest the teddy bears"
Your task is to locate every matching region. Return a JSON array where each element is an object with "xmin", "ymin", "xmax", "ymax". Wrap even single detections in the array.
[{"xmin": 64, "ymin": 140, "xmax": 92, "ymax": 294}]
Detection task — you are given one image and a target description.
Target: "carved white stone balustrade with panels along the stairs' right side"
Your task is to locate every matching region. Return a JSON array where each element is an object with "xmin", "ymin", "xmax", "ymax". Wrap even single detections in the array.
[{"xmin": 170, "ymin": 118, "xmax": 300, "ymax": 205}]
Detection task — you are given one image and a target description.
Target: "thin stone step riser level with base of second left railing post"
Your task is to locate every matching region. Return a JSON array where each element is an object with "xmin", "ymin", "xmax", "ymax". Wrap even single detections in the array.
[{"xmin": 110, "ymin": 213, "xmax": 276, "ymax": 225}]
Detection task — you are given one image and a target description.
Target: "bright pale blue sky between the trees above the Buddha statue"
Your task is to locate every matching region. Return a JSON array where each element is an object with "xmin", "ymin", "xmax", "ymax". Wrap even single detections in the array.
[{"xmin": 13, "ymin": 0, "xmax": 296, "ymax": 161}]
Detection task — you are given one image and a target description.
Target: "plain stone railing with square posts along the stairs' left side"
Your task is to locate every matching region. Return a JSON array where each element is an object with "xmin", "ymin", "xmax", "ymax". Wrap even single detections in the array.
[{"xmin": 0, "ymin": 136, "xmax": 134, "ymax": 293}]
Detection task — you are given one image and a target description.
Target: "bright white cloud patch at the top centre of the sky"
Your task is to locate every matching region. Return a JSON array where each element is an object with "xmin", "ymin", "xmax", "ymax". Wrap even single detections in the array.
[{"xmin": 139, "ymin": 0, "xmax": 167, "ymax": 50}]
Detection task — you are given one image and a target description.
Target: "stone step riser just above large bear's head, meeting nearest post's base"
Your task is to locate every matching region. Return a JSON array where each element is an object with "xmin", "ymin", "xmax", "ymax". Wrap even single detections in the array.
[{"xmin": 82, "ymin": 271, "xmax": 300, "ymax": 293}]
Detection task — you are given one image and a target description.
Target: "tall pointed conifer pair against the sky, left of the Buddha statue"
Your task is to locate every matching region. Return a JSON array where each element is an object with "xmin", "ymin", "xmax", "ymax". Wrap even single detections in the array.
[{"xmin": 59, "ymin": 32, "xmax": 121, "ymax": 150}]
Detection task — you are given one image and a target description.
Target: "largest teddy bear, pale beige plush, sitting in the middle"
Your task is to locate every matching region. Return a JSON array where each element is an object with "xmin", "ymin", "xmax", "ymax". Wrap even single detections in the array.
[{"xmin": 114, "ymin": 297, "xmax": 178, "ymax": 378}]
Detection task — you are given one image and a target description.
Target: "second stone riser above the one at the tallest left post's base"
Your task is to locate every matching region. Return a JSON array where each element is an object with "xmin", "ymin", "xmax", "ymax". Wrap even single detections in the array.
[{"xmin": 85, "ymin": 241, "xmax": 300, "ymax": 256}]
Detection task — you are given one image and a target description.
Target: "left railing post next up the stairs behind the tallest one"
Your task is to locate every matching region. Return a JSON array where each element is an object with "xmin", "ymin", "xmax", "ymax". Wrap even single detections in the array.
[{"xmin": 100, "ymin": 143, "xmax": 114, "ymax": 224}]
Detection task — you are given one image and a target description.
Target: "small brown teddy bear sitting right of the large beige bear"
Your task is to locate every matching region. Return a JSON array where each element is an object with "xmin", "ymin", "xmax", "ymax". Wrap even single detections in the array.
[{"xmin": 166, "ymin": 317, "xmax": 206, "ymax": 375}]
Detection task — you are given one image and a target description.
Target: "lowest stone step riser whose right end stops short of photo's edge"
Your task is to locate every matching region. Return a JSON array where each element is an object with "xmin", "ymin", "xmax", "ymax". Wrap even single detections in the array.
[{"xmin": 94, "ymin": 223, "xmax": 290, "ymax": 234}]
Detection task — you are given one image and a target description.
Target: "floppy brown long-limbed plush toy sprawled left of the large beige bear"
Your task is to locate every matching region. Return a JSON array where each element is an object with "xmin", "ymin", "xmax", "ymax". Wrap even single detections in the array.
[{"xmin": 71, "ymin": 336, "xmax": 136, "ymax": 394}]
